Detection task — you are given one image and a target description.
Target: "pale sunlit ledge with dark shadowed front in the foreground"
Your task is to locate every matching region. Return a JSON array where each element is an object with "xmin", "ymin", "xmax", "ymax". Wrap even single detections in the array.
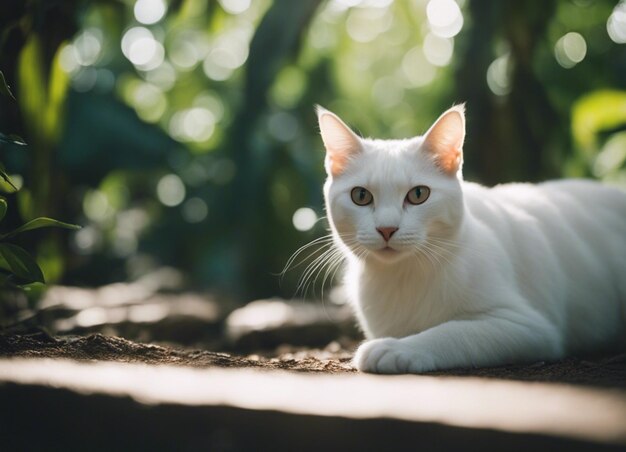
[{"xmin": 0, "ymin": 358, "xmax": 626, "ymax": 450}]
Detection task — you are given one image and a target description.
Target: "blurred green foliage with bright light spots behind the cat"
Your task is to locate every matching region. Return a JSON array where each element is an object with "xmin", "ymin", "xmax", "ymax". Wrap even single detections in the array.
[{"xmin": 0, "ymin": 0, "xmax": 626, "ymax": 348}]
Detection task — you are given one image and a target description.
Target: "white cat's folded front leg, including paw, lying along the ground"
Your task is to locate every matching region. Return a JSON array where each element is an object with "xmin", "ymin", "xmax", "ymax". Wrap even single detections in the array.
[{"xmin": 353, "ymin": 310, "xmax": 563, "ymax": 374}]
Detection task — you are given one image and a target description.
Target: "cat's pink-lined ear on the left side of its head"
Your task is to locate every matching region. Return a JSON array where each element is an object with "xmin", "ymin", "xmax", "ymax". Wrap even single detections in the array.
[{"xmin": 315, "ymin": 105, "xmax": 361, "ymax": 176}]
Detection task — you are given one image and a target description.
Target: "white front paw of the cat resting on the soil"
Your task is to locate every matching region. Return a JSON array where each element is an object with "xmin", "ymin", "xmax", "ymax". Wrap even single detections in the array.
[{"xmin": 352, "ymin": 337, "xmax": 435, "ymax": 374}]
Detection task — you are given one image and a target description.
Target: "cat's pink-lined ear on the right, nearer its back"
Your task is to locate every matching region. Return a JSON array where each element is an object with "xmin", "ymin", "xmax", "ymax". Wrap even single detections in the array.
[{"xmin": 422, "ymin": 104, "xmax": 465, "ymax": 176}]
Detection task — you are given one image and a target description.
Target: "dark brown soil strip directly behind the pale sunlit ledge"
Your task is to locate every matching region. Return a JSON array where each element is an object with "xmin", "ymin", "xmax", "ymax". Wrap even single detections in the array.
[{"xmin": 0, "ymin": 330, "xmax": 626, "ymax": 388}]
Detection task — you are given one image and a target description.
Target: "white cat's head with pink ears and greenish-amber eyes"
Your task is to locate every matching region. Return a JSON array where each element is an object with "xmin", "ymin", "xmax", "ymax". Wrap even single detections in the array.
[{"xmin": 317, "ymin": 106, "xmax": 465, "ymax": 262}]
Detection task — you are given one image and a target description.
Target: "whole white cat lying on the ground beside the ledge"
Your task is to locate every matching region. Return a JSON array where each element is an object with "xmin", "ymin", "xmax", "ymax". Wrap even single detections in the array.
[{"xmin": 318, "ymin": 106, "xmax": 626, "ymax": 374}]
